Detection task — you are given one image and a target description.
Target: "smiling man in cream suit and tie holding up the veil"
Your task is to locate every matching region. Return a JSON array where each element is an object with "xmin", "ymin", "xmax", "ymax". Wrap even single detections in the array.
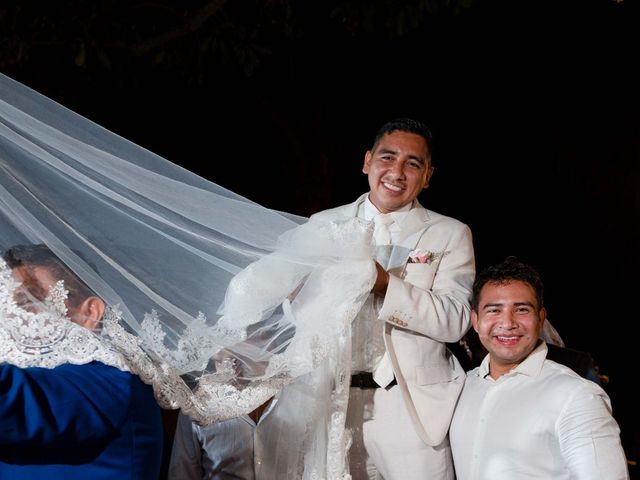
[{"xmin": 311, "ymin": 118, "xmax": 475, "ymax": 480}]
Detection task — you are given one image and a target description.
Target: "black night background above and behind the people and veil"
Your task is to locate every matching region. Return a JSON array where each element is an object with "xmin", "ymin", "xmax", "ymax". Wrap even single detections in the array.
[{"xmin": 0, "ymin": 0, "xmax": 640, "ymax": 473}]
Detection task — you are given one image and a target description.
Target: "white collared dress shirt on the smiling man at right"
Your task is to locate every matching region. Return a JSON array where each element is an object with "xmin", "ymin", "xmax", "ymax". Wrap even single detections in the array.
[{"xmin": 450, "ymin": 343, "xmax": 629, "ymax": 480}]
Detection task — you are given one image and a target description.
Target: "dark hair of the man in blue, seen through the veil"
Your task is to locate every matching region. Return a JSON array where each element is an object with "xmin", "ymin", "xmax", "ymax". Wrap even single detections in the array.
[{"xmin": 2, "ymin": 244, "xmax": 95, "ymax": 307}]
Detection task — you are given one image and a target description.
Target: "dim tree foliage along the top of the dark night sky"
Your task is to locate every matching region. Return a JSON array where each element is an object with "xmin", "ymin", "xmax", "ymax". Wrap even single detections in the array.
[{"xmin": 0, "ymin": 0, "xmax": 472, "ymax": 80}]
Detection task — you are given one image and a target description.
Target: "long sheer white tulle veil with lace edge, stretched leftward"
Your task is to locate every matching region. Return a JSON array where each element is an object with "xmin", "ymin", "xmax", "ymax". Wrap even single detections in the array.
[{"xmin": 0, "ymin": 75, "xmax": 375, "ymax": 479}]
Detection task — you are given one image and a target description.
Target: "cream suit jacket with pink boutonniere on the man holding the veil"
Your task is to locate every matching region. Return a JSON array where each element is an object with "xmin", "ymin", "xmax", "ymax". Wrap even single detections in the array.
[{"xmin": 311, "ymin": 193, "xmax": 475, "ymax": 446}]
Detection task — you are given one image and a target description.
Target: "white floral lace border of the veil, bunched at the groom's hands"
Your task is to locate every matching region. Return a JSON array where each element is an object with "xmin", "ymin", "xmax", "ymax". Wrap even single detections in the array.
[{"xmin": 0, "ymin": 219, "xmax": 375, "ymax": 480}]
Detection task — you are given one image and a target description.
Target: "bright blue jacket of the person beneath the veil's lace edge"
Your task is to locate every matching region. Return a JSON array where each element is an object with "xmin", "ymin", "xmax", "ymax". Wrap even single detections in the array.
[{"xmin": 0, "ymin": 362, "xmax": 163, "ymax": 480}]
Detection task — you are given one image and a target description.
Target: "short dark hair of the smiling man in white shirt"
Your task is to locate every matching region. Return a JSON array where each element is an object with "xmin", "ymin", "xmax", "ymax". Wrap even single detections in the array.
[{"xmin": 471, "ymin": 257, "xmax": 544, "ymax": 312}]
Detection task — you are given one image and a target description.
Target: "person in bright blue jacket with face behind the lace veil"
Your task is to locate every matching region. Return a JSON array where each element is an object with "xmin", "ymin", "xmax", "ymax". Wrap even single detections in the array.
[{"xmin": 0, "ymin": 244, "xmax": 163, "ymax": 480}]
